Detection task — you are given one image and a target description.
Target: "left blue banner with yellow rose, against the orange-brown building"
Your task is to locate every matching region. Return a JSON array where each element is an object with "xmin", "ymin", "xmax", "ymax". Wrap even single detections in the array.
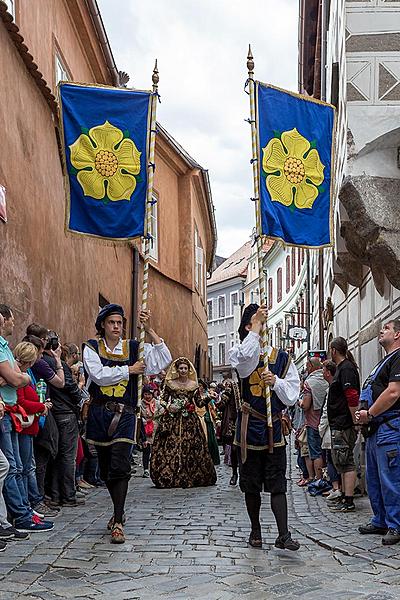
[{"xmin": 60, "ymin": 83, "xmax": 151, "ymax": 240}]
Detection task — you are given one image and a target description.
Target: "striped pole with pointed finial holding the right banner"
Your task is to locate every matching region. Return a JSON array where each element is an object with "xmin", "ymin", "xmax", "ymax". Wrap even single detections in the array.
[{"xmin": 247, "ymin": 45, "xmax": 274, "ymax": 453}]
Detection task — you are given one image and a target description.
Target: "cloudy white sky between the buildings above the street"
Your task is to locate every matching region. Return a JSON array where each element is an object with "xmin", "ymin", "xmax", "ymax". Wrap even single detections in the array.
[{"xmin": 98, "ymin": 0, "xmax": 298, "ymax": 257}]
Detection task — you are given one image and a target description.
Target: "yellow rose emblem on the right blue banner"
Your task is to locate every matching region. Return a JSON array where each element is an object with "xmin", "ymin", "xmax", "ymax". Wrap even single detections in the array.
[{"xmin": 262, "ymin": 128, "xmax": 325, "ymax": 208}]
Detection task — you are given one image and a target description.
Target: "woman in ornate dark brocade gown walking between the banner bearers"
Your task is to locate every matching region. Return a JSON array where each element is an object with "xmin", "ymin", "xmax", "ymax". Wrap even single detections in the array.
[{"xmin": 150, "ymin": 358, "xmax": 217, "ymax": 488}]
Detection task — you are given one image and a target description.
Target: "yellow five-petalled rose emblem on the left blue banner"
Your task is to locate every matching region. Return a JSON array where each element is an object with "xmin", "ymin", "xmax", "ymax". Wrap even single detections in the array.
[{"xmin": 69, "ymin": 121, "xmax": 141, "ymax": 201}]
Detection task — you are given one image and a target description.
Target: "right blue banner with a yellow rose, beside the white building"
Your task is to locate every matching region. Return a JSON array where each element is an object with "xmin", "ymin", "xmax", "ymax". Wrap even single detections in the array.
[{"xmin": 256, "ymin": 82, "xmax": 335, "ymax": 248}]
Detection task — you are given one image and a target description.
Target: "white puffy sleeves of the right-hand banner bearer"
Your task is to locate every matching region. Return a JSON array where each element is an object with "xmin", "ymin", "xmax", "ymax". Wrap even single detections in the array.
[{"xmin": 228, "ymin": 331, "xmax": 300, "ymax": 406}]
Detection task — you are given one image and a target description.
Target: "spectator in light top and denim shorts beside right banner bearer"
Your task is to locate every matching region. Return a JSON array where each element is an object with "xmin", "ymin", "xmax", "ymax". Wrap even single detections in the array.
[{"xmin": 300, "ymin": 357, "xmax": 328, "ymax": 479}]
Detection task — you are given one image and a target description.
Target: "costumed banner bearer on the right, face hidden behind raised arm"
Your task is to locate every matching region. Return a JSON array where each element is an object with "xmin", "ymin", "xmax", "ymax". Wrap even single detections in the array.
[{"xmin": 229, "ymin": 304, "xmax": 300, "ymax": 550}]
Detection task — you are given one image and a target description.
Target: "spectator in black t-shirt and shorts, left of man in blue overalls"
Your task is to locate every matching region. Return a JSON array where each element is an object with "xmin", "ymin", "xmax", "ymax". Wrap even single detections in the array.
[{"xmin": 327, "ymin": 337, "xmax": 360, "ymax": 512}]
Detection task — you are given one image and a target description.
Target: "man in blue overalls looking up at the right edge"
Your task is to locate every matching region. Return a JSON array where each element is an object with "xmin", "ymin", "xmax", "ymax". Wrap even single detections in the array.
[{"xmin": 356, "ymin": 319, "xmax": 400, "ymax": 546}]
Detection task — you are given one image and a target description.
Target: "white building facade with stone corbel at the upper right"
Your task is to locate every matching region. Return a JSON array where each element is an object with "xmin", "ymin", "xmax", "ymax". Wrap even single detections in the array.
[{"xmin": 300, "ymin": 0, "xmax": 400, "ymax": 377}]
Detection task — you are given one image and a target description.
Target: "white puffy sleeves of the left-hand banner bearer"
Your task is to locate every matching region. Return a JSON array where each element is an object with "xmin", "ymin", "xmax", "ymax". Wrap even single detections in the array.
[{"xmin": 83, "ymin": 340, "xmax": 172, "ymax": 387}]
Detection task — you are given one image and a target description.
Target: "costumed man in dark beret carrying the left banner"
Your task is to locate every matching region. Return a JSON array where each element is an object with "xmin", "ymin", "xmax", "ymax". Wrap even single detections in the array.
[{"xmin": 83, "ymin": 304, "xmax": 172, "ymax": 544}]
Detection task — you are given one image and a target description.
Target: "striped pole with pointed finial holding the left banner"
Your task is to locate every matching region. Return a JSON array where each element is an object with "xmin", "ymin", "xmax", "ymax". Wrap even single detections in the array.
[{"xmin": 136, "ymin": 60, "xmax": 160, "ymax": 418}]
